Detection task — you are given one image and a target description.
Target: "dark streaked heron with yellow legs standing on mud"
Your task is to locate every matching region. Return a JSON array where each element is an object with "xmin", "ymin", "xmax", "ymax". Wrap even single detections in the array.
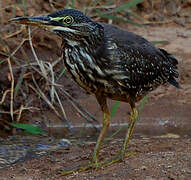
[{"xmin": 10, "ymin": 9, "xmax": 180, "ymax": 175}]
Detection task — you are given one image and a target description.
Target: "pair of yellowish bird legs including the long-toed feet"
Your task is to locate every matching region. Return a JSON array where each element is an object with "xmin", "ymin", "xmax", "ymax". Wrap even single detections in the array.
[{"xmin": 61, "ymin": 99, "xmax": 138, "ymax": 176}]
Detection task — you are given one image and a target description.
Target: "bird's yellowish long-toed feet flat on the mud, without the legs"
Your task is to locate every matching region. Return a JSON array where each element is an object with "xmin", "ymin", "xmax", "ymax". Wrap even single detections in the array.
[{"xmin": 61, "ymin": 152, "xmax": 136, "ymax": 176}]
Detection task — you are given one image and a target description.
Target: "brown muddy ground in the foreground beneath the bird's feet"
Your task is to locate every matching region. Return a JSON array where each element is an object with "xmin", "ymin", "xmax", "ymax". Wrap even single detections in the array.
[{"xmin": 1, "ymin": 137, "xmax": 191, "ymax": 180}]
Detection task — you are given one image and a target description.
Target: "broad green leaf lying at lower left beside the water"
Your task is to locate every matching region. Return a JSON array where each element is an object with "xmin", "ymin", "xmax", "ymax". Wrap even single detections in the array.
[{"xmin": 11, "ymin": 123, "xmax": 47, "ymax": 136}]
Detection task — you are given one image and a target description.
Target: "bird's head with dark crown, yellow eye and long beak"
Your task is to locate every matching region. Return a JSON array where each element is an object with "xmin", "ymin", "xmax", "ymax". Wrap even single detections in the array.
[{"xmin": 10, "ymin": 9, "xmax": 103, "ymax": 43}]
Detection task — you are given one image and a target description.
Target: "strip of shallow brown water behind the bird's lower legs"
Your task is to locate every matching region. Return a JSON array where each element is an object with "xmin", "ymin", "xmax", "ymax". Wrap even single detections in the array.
[{"xmin": 49, "ymin": 121, "xmax": 191, "ymax": 138}]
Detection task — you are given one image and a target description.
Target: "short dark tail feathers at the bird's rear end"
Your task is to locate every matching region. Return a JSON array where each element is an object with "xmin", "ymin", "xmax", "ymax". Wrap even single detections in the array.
[{"xmin": 160, "ymin": 48, "xmax": 181, "ymax": 88}]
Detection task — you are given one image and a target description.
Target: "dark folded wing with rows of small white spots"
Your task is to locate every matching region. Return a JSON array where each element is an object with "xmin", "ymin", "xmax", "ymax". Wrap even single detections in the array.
[{"xmin": 97, "ymin": 24, "xmax": 180, "ymax": 92}]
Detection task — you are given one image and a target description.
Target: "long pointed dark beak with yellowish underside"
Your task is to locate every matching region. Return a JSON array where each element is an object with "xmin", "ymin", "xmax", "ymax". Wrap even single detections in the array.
[{"xmin": 9, "ymin": 16, "xmax": 53, "ymax": 28}]
